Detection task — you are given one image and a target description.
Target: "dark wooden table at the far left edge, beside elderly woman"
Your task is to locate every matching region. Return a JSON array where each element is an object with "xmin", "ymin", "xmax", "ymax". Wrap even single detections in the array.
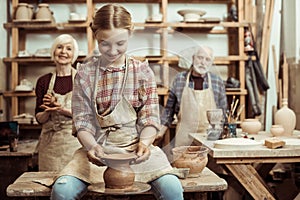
[{"xmin": 0, "ymin": 140, "xmax": 37, "ymax": 200}]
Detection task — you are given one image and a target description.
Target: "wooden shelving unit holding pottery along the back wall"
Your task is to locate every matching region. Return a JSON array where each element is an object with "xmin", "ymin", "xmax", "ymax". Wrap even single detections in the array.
[{"xmin": 3, "ymin": 0, "xmax": 253, "ymax": 120}]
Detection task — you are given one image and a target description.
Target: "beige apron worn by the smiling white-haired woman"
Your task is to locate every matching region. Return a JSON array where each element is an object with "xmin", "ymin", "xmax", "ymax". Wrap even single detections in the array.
[{"xmin": 38, "ymin": 69, "xmax": 81, "ymax": 171}]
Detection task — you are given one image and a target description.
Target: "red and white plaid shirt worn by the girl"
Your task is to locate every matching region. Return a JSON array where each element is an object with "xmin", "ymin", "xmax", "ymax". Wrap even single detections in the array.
[{"xmin": 72, "ymin": 57, "xmax": 159, "ymax": 134}]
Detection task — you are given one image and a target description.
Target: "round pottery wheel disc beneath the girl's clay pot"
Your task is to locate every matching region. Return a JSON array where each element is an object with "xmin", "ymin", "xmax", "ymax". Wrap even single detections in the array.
[{"xmin": 88, "ymin": 182, "xmax": 151, "ymax": 195}]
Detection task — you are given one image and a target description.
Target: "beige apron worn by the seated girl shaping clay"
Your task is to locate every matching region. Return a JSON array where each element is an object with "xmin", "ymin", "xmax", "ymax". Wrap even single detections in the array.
[{"xmin": 57, "ymin": 59, "xmax": 173, "ymax": 184}]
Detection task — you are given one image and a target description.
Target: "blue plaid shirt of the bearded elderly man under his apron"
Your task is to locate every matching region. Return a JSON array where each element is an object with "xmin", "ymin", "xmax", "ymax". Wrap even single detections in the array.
[{"xmin": 161, "ymin": 71, "xmax": 228, "ymax": 126}]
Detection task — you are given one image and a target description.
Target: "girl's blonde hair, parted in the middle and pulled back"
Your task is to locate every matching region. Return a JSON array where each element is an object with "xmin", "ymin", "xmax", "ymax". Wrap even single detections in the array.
[{"xmin": 90, "ymin": 4, "xmax": 133, "ymax": 34}]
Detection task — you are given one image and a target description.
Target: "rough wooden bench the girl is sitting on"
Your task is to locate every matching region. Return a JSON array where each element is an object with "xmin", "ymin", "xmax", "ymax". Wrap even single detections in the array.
[{"xmin": 6, "ymin": 168, "xmax": 227, "ymax": 200}]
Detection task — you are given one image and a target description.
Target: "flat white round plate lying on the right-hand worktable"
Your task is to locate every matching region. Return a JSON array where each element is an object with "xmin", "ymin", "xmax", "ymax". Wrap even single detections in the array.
[{"xmin": 214, "ymin": 138, "xmax": 262, "ymax": 149}]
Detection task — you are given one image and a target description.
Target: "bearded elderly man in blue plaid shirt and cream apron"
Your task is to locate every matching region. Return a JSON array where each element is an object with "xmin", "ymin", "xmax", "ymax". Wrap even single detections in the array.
[{"xmin": 156, "ymin": 46, "xmax": 228, "ymax": 146}]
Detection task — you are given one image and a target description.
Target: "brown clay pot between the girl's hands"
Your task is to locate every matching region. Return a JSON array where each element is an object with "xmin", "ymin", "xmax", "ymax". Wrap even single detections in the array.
[{"xmin": 101, "ymin": 154, "xmax": 136, "ymax": 189}]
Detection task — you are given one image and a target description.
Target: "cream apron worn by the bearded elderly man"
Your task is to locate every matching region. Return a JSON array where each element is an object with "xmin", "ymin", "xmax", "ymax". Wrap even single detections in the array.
[{"xmin": 175, "ymin": 71, "xmax": 216, "ymax": 147}]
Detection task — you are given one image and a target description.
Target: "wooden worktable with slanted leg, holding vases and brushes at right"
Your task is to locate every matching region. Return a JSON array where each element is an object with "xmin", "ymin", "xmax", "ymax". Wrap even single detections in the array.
[{"xmin": 190, "ymin": 133, "xmax": 300, "ymax": 199}]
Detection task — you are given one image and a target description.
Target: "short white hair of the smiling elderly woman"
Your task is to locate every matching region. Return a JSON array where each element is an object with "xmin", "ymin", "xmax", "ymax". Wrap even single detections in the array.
[{"xmin": 50, "ymin": 34, "xmax": 79, "ymax": 64}]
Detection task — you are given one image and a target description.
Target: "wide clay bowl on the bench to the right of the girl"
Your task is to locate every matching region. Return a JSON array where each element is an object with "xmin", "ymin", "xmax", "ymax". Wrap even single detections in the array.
[{"xmin": 172, "ymin": 146, "xmax": 209, "ymax": 177}]
